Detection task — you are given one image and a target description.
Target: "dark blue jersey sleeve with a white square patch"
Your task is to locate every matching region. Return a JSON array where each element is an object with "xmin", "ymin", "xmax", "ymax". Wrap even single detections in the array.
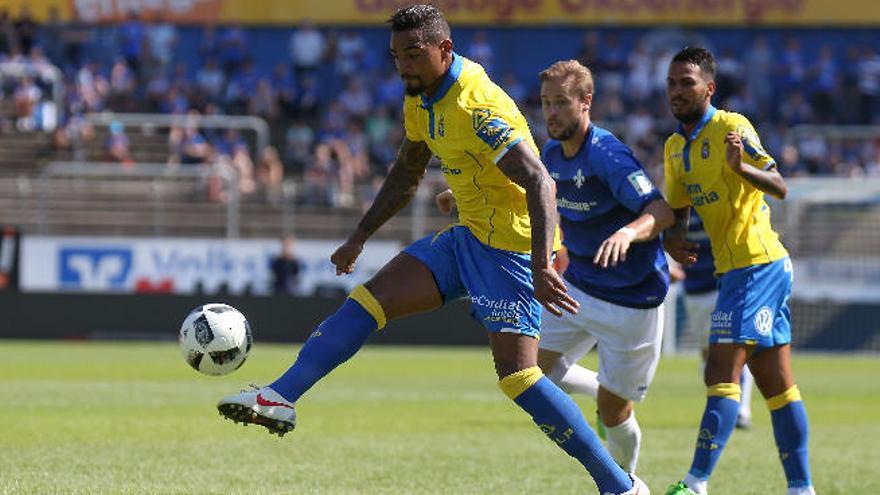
[{"xmin": 593, "ymin": 140, "xmax": 663, "ymax": 213}]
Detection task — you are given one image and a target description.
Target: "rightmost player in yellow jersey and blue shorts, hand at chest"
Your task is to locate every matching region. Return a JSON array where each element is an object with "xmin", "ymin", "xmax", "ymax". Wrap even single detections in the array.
[{"xmin": 664, "ymin": 48, "xmax": 815, "ymax": 495}]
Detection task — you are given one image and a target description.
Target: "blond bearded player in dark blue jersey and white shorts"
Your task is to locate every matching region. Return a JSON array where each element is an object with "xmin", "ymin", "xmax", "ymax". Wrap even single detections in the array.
[{"xmin": 438, "ymin": 60, "xmax": 674, "ymax": 473}]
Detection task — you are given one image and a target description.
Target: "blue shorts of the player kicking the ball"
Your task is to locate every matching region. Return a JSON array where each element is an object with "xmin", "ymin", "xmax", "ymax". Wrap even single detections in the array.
[{"xmin": 404, "ymin": 225, "xmax": 542, "ymax": 338}]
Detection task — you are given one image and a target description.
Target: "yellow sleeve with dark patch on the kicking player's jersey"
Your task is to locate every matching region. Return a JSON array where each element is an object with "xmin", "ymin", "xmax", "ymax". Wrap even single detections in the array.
[{"xmin": 464, "ymin": 94, "xmax": 528, "ymax": 163}]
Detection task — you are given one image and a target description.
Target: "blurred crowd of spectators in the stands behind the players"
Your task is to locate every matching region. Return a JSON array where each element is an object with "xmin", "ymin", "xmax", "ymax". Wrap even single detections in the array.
[{"xmin": 0, "ymin": 7, "xmax": 880, "ymax": 207}]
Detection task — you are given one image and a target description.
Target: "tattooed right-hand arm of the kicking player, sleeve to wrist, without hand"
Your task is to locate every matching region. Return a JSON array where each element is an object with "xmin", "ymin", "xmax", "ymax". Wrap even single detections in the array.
[{"xmin": 498, "ymin": 143, "xmax": 559, "ymax": 268}]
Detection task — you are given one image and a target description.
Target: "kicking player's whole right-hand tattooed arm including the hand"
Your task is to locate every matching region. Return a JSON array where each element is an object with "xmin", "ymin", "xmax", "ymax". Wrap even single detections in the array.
[{"xmin": 498, "ymin": 142, "xmax": 578, "ymax": 316}]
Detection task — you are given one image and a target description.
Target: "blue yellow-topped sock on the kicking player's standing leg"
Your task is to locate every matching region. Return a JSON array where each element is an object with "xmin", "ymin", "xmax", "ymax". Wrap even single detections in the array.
[{"xmin": 499, "ymin": 367, "xmax": 633, "ymax": 493}]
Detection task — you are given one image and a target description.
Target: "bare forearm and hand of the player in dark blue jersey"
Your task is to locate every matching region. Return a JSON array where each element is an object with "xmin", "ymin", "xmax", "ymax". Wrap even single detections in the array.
[{"xmin": 593, "ymin": 199, "xmax": 675, "ymax": 268}]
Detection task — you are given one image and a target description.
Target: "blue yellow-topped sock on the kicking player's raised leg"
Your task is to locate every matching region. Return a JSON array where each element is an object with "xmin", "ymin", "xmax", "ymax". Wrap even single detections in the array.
[{"xmin": 269, "ymin": 285, "xmax": 385, "ymax": 402}]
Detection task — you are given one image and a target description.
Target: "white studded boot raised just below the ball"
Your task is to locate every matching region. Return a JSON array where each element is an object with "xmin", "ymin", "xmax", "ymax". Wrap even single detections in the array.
[{"xmin": 217, "ymin": 385, "xmax": 296, "ymax": 437}]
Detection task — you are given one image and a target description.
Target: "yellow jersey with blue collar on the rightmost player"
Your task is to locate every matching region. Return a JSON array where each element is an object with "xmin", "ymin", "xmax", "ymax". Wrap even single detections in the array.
[{"xmin": 663, "ymin": 106, "xmax": 788, "ymax": 274}]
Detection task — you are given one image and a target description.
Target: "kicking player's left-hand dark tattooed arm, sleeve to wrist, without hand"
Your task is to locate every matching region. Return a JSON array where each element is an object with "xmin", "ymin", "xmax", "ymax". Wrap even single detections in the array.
[{"xmin": 352, "ymin": 138, "xmax": 431, "ymax": 243}]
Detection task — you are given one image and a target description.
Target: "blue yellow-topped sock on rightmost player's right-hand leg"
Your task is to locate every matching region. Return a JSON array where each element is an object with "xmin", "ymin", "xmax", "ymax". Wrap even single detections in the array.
[{"xmin": 767, "ymin": 385, "xmax": 813, "ymax": 488}]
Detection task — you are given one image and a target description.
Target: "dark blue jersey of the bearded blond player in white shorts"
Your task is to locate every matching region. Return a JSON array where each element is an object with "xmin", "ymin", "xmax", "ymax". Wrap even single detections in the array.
[{"xmin": 541, "ymin": 125, "xmax": 669, "ymax": 308}]
